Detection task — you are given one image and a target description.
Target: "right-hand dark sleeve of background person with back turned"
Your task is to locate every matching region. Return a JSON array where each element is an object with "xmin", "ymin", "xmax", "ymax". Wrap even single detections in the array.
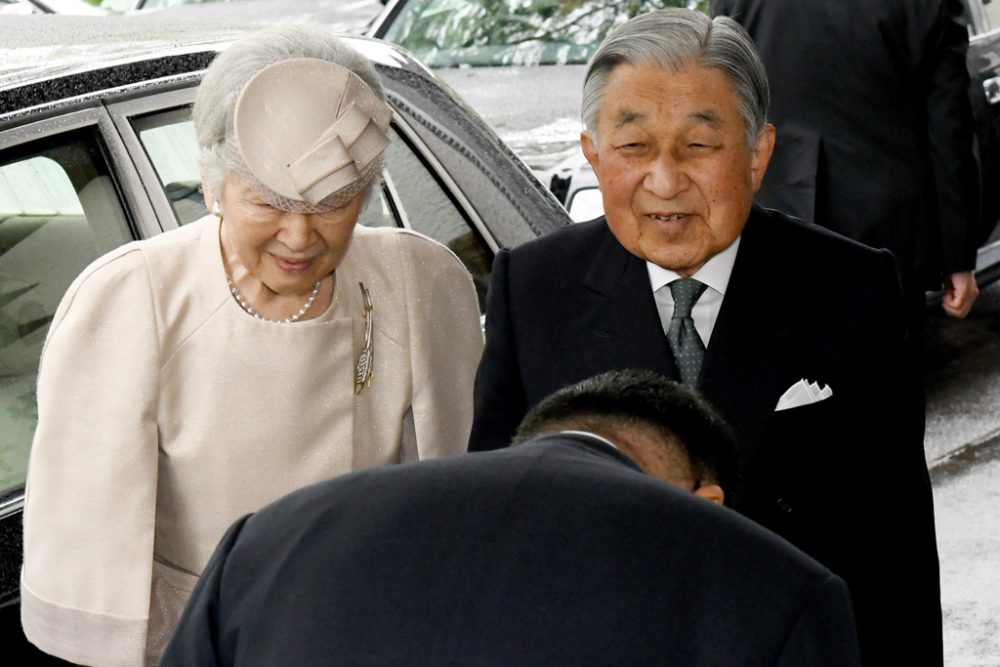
[{"xmin": 921, "ymin": 0, "xmax": 979, "ymax": 275}]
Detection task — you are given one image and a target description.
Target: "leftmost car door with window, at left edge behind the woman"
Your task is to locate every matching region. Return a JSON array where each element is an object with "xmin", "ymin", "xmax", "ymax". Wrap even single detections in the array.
[{"xmin": 0, "ymin": 105, "xmax": 143, "ymax": 664}]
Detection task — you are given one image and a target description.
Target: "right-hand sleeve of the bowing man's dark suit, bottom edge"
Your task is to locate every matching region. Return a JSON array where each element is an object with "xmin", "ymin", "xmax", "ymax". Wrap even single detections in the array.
[{"xmin": 775, "ymin": 575, "xmax": 861, "ymax": 667}]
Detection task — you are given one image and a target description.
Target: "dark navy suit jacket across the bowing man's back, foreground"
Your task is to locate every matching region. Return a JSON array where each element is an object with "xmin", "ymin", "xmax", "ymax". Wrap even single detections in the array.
[{"xmin": 162, "ymin": 434, "xmax": 859, "ymax": 667}]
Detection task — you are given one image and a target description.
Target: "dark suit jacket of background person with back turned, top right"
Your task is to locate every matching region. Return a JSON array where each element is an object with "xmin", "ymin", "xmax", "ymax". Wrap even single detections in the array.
[{"xmin": 711, "ymin": 0, "xmax": 979, "ymax": 288}]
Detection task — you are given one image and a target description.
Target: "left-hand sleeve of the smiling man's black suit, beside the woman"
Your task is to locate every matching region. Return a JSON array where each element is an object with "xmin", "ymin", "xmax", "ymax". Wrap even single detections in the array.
[{"xmin": 469, "ymin": 250, "xmax": 527, "ymax": 452}]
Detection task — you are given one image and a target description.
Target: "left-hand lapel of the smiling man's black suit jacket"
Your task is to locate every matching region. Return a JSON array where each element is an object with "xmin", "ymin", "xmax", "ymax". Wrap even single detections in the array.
[{"xmin": 577, "ymin": 224, "xmax": 677, "ymax": 378}]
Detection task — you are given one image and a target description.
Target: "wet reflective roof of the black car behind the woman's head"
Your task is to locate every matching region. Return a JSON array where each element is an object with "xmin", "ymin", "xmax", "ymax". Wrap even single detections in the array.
[{"xmin": 0, "ymin": 15, "xmax": 426, "ymax": 118}]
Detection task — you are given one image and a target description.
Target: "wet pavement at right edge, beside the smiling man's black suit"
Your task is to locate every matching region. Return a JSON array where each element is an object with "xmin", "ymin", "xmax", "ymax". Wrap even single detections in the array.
[{"xmin": 925, "ymin": 284, "xmax": 1000, "ymax": 667}]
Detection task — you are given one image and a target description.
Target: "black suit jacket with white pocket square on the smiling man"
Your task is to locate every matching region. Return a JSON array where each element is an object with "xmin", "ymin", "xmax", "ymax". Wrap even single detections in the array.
[{"xmin": 470, "ymin": 206, "xmax": 942, "ymax": 664}]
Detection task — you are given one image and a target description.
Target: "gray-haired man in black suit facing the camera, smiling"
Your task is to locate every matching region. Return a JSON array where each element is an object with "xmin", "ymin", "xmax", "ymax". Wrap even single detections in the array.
[{"xmin": 470, "ymin": 9, "xmax": 941, "ymax": 664}]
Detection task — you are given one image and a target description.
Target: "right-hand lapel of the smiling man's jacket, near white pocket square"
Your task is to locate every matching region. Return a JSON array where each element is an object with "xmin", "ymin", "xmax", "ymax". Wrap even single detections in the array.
[{"xmin": 698, "ymin": 207, "xmax": 799, "ymax": 460}]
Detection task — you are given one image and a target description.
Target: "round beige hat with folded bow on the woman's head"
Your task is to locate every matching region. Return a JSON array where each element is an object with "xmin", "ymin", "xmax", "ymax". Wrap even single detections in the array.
[{"xmin": 233, "ymin": 58, "xmax": 392, "ymax": 205}]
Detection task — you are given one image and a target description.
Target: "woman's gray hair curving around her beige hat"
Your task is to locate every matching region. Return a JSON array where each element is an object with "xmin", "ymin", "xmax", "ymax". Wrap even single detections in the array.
[{"xmin": 192, "ymin": 24, "xmax": 385, "ymax": 206}]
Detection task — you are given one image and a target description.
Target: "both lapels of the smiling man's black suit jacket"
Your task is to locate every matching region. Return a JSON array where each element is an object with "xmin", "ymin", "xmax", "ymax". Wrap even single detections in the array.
[{"xmin": 564, "ymin": 217, "xmax": 801, "ymax": 460}]
